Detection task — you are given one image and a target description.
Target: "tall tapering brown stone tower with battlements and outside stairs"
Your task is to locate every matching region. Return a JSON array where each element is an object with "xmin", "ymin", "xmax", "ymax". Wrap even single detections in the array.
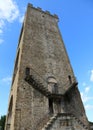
[{"xmin": 5, "ymin": 4, "xmax": 89, "ymax": 130}]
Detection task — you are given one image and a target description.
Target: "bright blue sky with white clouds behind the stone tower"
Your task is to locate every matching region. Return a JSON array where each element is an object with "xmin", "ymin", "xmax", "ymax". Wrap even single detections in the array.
[{"xmin": 0, "ymin": 0, "xmax": 93, "ymax": 121}]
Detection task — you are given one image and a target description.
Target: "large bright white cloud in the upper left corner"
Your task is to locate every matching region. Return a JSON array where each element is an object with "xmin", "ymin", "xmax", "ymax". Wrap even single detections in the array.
[{"xmin": 0, "ymin": 0, "xmax": 19, "ymax": 34}]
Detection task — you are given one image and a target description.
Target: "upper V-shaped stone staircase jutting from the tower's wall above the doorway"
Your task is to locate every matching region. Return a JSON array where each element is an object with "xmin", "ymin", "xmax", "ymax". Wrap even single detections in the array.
[{"xmin": 25, "ymin": 68, "xmax": 78, "ymax": 99}]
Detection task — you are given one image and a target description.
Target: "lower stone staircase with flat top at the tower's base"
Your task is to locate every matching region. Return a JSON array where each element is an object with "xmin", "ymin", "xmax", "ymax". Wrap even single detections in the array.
[{"xmin": 41, "ymin": 113, "xmax": 88, "ymax": 130}]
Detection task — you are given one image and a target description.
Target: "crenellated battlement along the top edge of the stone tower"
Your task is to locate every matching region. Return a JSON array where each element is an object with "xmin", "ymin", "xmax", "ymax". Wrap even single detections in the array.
[{"xmin": 28, "ymin": 3, "xmax": 59, "ymax": 19}]
